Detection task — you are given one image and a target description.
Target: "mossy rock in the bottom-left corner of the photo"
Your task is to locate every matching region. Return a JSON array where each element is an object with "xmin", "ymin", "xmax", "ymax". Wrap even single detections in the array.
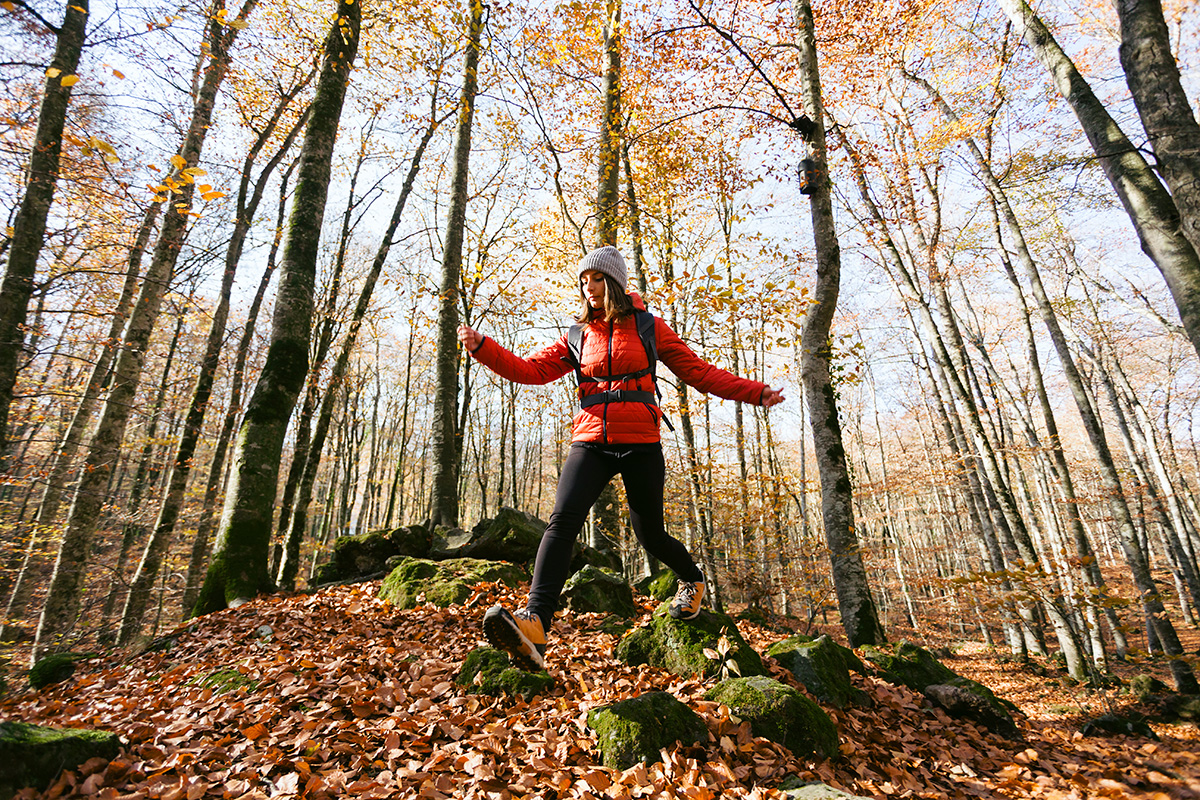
[{"xmin": 0, "ymin": 721, "xmax": 121, "ymax": 798}]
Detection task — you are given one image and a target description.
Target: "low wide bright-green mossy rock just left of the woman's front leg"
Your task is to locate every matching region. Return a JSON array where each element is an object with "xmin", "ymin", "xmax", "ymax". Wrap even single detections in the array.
[{"xmin": 379, "ymin": 558, "xmax": 528, "ymax": 608}]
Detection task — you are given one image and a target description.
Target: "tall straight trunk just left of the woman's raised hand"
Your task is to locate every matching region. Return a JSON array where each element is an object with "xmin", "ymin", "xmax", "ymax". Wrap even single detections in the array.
[{"xmin": 430, "ymin": 0, "xmax": 484, "ymax": 527}]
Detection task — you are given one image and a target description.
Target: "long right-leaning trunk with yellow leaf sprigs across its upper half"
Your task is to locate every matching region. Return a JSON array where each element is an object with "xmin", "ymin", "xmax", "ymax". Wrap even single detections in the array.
[{"xmin": 34, "ymin": 0, "xmax": 258, "ymax": 660}]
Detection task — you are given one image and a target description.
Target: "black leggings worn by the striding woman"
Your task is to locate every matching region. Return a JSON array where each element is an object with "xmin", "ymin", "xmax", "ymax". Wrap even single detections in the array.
[{"xmin": 527, "ymin": 443, "xmax": 704, "ymax": 631}]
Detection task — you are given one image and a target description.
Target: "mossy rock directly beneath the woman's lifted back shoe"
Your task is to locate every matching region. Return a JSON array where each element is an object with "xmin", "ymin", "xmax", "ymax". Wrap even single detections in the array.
[{"xmin": 614, "ymin": 603, "xmax": 766, "ymax": 678}]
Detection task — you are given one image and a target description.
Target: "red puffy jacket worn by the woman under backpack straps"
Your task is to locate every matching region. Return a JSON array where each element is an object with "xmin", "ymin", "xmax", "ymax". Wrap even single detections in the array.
[{"xmin": 472, "ymin": 293, "xmax": 767, "ymax": 444}]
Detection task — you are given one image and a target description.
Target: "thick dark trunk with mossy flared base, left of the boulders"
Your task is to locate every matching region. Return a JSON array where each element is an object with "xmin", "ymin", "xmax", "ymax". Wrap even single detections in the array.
[{"xmin": 193, "ymin": 0, "xmax": 361, "ymax": 615}]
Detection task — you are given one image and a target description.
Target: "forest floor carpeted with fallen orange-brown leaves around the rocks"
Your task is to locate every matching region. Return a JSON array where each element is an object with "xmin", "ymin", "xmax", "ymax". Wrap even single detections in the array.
[{"xmin": 0, "ymin": 582, "xmax": 1200, "ymax": 800}]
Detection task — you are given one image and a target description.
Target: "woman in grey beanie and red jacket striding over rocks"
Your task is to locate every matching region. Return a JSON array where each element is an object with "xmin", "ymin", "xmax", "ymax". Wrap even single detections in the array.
[{"xmin": 458, "ymin": 246, "xmax": 784, "ymax": 670}]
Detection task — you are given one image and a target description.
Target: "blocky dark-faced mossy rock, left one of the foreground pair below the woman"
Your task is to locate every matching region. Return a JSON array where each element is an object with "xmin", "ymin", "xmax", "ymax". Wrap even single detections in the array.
[{"xmin": 588, "ymin": 692, "xmax": 708, "ymax": 770}]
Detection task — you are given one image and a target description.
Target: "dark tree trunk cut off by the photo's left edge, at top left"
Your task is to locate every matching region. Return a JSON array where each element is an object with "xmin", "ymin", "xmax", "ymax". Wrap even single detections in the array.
[{"xmin": 0, "ymin": 0, "xmax": 89, "ymax": 453}]
